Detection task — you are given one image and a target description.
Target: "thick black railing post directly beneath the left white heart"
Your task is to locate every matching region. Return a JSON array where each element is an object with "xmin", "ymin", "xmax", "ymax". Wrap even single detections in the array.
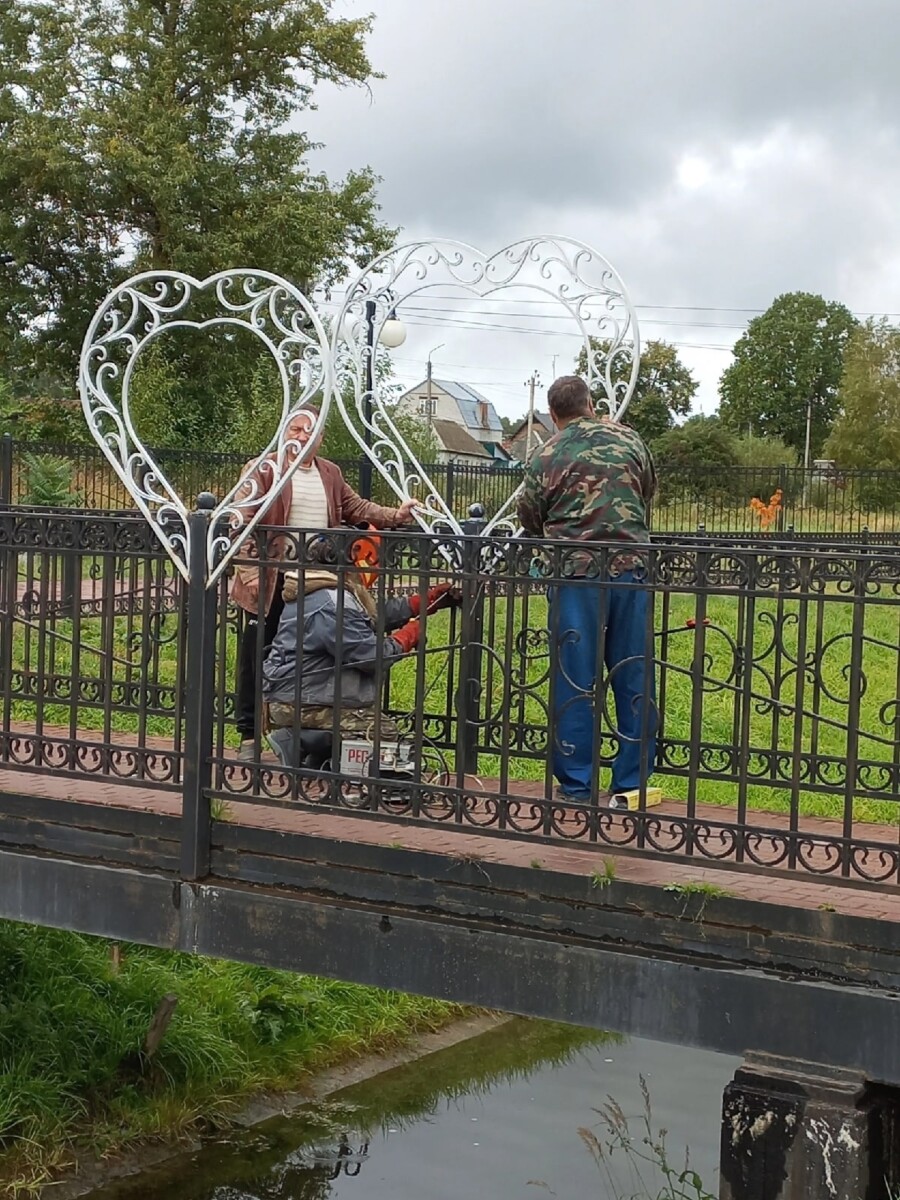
[{"xmin": 181, "ymin": 492, "xmax": 216, "ymax": 880}]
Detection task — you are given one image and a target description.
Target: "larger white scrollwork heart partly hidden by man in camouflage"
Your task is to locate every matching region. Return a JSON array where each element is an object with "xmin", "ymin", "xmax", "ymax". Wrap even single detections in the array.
[{"xmin": 332, "ymin": 236, "xmax": 641, "ymax": 534}]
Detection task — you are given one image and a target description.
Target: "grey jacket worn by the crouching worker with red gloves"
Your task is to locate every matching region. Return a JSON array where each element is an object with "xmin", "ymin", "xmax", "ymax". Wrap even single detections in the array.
[{"xmin": 263, "ymin": 581, "xmax": 412, "ymax": 708}]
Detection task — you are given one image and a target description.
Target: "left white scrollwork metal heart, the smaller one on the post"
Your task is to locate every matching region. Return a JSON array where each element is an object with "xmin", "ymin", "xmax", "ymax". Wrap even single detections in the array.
[{"xmin": 78, "ymin": 270, "xmax": 332, "ymax": 586}]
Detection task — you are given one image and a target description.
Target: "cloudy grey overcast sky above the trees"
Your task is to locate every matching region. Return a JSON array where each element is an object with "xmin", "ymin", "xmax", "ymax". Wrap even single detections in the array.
[{"xmin": 302, "ymin": 0, "xmax": 900, "ymax": 416}]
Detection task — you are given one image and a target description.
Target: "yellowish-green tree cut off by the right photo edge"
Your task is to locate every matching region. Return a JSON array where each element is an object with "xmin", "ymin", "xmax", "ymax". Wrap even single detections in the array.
[{"xmin": 826, "ymin": 320, "xmax": 900, "ymax": 470}]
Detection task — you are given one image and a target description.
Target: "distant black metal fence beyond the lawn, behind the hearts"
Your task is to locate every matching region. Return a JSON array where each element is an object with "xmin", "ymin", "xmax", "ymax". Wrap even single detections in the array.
[{"xmin": 7, "ymin": 438, "xmax": 900, "ymax": 541}]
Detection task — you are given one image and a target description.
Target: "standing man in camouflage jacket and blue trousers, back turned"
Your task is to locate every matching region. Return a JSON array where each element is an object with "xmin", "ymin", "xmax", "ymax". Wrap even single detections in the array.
[{"xmin": 518, "ymin": 376, "xmax": 658, "ymax": 808}]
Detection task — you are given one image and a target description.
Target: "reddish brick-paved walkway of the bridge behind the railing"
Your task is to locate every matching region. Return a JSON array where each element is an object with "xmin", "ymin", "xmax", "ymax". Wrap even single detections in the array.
[{"xmin": 0, "ymin": 726, "xmax": 900, "ymax": 920}]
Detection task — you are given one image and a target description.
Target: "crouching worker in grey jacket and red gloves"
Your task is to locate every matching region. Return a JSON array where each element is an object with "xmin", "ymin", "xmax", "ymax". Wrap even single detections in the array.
[{"xmin": 263, "ymin": 539, "xmax": 457, "ymax": 766}]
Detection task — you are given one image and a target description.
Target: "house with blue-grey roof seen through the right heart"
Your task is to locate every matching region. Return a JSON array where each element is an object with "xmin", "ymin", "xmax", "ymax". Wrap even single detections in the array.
[{"xmin": 397, "ymin": 379, "xmax": 510, "ymax": 467}]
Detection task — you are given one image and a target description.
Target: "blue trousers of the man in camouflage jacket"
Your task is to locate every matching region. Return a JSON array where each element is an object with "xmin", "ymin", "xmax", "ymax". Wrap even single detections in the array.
[{"xmin": 550, "ymin": 571, "xmax": 659, "ymax": 799}]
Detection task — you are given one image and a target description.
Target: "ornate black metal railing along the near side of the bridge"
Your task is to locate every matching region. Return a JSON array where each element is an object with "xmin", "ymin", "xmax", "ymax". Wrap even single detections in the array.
[{"xmin": 0, "ymin": 508, "xmax": 900, "ymax": 886}]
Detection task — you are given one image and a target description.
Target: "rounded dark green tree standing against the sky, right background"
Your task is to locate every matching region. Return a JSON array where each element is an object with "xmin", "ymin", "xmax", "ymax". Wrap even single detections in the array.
[{"xmin": 719, "ymin": 292, "xmax": 858, "ymax": 456}]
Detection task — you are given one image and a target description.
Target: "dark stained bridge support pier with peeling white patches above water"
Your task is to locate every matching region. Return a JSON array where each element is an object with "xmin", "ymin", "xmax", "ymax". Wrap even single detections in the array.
[{"xmin": 719, "ymin": 1054, "xmax": 900, "ymax": 1200}]
